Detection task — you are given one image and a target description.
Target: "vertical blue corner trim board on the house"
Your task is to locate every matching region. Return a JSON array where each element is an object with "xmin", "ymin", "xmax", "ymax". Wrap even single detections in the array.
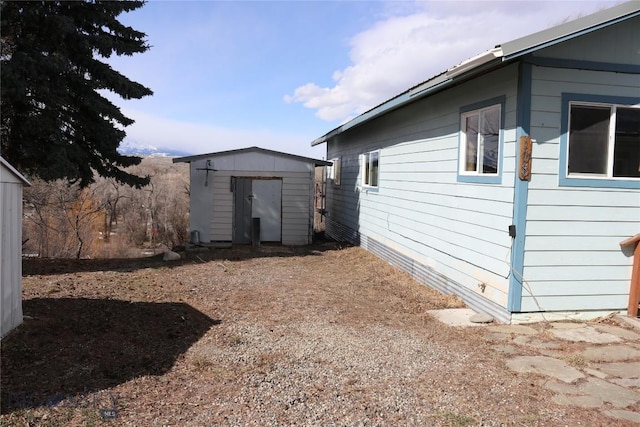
[{"xmin": 507, "ymin": 60, "xmax": 533, "ymax": 313}]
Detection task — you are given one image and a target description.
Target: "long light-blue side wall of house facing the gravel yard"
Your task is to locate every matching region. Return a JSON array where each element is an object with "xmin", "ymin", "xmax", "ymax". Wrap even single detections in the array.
[{"xmin": 327, "ymin": 66, "xmax": 517, "ymax": 307}]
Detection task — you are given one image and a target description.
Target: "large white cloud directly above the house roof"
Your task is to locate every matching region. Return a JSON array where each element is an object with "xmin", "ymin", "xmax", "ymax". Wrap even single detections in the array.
[{"xmin": 284, "ymin": 2, "xmax": 611, "ymax": 122}]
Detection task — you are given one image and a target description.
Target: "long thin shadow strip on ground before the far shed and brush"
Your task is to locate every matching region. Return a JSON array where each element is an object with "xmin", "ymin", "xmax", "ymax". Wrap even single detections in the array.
[{"xmin": 22, "ymin": 241, "xmax": 349, "ymax": 276}]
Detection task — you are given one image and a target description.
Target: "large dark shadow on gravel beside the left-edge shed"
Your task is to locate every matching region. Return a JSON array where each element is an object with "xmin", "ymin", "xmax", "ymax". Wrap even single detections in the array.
[{"xmin": 1, "ymin": 298, "xmax": 220, "ymax": 413}]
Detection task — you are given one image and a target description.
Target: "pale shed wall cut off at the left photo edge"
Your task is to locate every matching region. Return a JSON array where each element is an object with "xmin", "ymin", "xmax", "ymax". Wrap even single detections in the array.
[{"xmin": 0, "ymin": 164, "xmax": 22, "ymax": 337}]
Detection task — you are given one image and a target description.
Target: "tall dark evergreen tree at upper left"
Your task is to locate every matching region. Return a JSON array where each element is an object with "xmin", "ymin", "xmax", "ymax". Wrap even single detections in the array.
[{"xmin": 0, "ymin": 0, "xmax": 152, "ymax": 187}]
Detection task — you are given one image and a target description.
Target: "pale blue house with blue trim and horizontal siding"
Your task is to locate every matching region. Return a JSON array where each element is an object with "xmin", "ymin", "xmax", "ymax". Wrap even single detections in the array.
[{"xmin": 312, "ymin": 2, "xmax": 640, "ymax": 322}]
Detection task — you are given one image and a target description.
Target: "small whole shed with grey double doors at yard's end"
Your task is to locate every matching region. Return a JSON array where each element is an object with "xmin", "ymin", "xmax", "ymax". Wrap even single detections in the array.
[{"xmin": 173, "ymin": 147, "xmax": 331, "ymax": 245}]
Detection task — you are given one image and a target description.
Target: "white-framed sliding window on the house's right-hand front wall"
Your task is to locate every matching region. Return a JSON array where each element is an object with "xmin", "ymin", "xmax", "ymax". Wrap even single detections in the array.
[{"xmin": 567, "ymin": 103, "xmax": 640, "ymax": 178}]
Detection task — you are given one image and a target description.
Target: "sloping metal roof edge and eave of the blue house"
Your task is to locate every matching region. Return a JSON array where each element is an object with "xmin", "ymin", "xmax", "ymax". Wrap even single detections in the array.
[{"xmin": 311, "ymin": 0, "xmax": 640, "ymax": 146}]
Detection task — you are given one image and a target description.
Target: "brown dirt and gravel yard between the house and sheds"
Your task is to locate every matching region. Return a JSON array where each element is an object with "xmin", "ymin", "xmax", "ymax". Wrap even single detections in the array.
[{"xmin": 0, "ymin": 242, "xmax": 636, "ymax": 426}]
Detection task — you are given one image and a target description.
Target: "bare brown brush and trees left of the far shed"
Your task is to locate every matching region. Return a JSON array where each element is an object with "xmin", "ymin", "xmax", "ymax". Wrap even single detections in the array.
[{"xmin": 23, "ymin": 159, "xmax": 189, "ymax": 258}]
